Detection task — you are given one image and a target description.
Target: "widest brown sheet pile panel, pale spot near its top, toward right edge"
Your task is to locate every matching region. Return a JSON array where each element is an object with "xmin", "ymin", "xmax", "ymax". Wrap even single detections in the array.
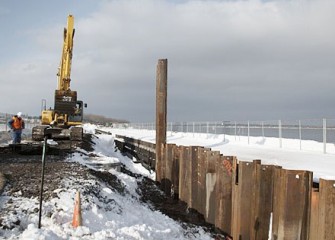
[{"xmin": 272, "ymin": 169, "xmax": 313, "ymax": 240}]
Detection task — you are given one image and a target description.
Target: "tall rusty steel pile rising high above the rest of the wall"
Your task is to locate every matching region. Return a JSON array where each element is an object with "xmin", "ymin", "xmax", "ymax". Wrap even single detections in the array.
[{"xmin": 155, "ymin": 59, "xmax": 167, "ymax": 182}]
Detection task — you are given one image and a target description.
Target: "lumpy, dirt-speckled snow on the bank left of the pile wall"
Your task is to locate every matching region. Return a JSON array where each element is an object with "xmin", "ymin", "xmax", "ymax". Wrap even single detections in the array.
[{"xmin": 0, "ymin": 125, "xmax": 212, "ymax": 240}]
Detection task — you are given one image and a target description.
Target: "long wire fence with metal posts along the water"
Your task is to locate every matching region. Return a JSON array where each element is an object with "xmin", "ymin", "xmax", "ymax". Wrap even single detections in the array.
[{"xmin": 114, "ymin": 118, "xmax": 335, "ymax": 153}]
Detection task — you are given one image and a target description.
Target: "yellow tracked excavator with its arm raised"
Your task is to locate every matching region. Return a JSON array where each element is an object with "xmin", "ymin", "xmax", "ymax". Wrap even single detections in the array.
[{"xmin": 32, "ymin": 15, "xmax": 87, "ymax": 141}]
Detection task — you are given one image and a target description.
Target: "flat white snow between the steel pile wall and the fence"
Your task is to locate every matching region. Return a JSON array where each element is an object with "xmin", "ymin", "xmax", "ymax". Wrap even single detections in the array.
[{"xmin": 112, "ymin": 125, "xmax": 335, "ymax": 182}]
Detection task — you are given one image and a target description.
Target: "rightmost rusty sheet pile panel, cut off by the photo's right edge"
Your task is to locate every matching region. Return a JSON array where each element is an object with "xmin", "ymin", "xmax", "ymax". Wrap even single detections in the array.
[{"xmin": 318, "ymin": 179, "xmax": 335, "ymax": 240}]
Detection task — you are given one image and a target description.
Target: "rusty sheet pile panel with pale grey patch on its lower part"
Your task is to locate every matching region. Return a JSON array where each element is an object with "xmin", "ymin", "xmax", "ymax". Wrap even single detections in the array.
[{"xmin": 205, "ymin": 151, "xmax": 220, "ymax": 224}]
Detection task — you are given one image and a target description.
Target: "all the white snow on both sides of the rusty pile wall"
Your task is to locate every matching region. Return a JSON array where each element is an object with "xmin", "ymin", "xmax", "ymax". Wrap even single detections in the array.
[{"xmin": 0, "ymin": 124, "xmax": 335, "ymax": 240}]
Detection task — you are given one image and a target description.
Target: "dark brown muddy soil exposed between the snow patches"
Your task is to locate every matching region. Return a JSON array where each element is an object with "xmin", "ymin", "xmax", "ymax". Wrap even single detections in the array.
[{"xmin": 0, "ymin": 135, "xmax": 225, "ymax": 239}]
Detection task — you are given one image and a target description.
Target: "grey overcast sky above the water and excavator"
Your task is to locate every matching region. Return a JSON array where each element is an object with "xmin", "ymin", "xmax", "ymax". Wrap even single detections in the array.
[{"xmin": 0, "ymin": 0, "xmax": 335, "ymax": 122}]
